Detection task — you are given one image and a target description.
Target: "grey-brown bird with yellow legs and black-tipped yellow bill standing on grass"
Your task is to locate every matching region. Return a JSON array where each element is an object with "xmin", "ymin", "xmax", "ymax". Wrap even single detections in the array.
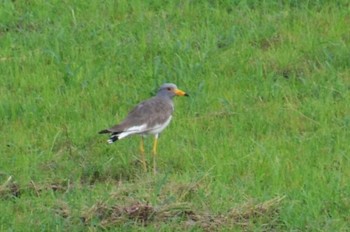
[{"xmin": 99, "ymin": 83, "xmax": 189, "ymax": 174}]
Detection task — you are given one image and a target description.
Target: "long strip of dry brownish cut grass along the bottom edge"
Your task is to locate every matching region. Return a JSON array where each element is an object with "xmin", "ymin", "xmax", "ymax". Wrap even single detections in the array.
[{"xmin": 81, "ymin": 196, "xmax": 284, "ymax": 231}]
